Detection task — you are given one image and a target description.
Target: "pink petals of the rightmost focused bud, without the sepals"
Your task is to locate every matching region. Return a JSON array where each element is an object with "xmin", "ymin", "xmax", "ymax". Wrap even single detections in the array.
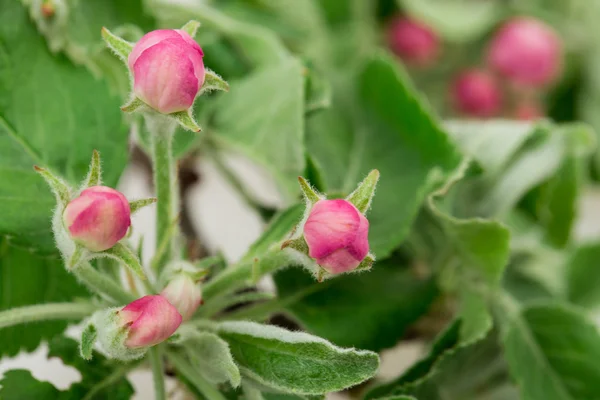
[{"xmin": 304, "ymin": 199, "xmax": 369, "ymax": 274}]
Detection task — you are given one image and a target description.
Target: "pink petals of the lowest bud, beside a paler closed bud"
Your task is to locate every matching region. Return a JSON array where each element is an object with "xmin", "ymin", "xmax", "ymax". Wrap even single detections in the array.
[{"xmin": 118, "ymin": 295, "xmax": 182, "ymax": 348}]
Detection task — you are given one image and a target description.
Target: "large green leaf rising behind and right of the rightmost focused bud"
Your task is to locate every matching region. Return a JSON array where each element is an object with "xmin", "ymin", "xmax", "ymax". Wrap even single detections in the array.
[{"xmin": 352, "ymin": 56, "xmax": 460, "ymax": 258}]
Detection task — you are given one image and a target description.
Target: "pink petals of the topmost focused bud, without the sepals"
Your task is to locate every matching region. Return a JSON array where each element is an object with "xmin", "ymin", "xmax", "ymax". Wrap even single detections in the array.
[{"xmin": 128, "ymin": 29, "xmax": 205, "ymax": 114}]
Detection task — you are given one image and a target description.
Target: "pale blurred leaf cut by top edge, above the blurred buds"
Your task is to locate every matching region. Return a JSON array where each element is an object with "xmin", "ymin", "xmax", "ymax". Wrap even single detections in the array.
[{"xmin": 398, "ymin": 0, "xmax": 505, "ymax": 43}]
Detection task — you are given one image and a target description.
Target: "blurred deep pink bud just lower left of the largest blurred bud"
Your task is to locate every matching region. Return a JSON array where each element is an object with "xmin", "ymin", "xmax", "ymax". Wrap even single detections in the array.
[{"xmin": 452, "ymin": 69, "xmax": 502, "ymax": 118}]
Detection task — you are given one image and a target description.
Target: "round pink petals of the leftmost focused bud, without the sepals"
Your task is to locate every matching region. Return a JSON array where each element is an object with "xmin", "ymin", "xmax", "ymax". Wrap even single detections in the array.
[{"xmin": 63, "ymin": 186, "xmax": 131, "ymax": 251}]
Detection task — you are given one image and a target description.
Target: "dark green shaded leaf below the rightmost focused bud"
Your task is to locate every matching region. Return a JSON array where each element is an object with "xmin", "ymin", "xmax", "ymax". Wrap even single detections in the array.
[{"xmin": 275, "ymin": 260, "xmax": 438, "ymax": 351}]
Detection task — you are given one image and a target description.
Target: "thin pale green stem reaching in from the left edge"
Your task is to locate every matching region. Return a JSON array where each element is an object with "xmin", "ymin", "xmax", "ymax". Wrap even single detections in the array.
[{"xmin": 0, "ymin": 303, "xmax": 97, "ymax": 329}]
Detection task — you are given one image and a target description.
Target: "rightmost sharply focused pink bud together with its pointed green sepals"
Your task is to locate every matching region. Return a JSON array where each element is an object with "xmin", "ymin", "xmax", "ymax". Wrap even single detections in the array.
[{"xmin": 282, "ymin": 170, "xmax": 379, "ymax": 281}]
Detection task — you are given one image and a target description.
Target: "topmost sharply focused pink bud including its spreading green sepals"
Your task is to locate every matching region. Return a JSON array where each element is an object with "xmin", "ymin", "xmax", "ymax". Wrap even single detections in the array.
[{"xmin": 102, "ymin": 21, "xmax": 229, "ymax": 132}]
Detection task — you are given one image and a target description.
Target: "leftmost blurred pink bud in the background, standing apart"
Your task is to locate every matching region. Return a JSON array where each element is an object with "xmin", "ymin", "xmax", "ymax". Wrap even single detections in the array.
[{"xmin": 387, "ymin": 16, "xmax": 440, "ymax": 67}]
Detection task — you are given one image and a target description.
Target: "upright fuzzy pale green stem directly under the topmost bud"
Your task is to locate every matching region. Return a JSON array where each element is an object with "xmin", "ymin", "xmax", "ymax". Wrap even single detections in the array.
[{"xmin": 146, "ymin": 114, "xmax": 178, "ymax": 270}]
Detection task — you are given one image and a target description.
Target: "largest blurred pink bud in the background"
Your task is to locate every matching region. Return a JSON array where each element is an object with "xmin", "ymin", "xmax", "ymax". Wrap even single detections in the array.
[{"xmin": 488, "ymin": 18, "xmax": 562, "ymax": 87}]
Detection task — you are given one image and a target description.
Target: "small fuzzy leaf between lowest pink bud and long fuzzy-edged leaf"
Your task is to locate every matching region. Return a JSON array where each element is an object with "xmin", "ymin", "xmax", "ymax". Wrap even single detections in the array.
[{"xmin": 186, "ymin": 332, "xmax": 241, "ymax": 387}]
